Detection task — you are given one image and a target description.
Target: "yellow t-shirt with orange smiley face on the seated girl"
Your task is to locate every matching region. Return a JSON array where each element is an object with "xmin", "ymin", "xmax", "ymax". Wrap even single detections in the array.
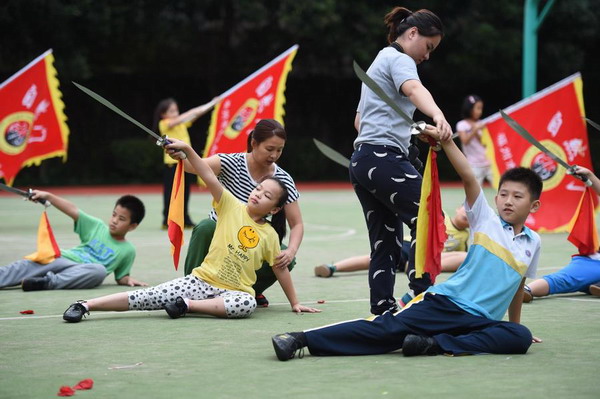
[{"xmin": 192, "ymin": 190, "xmax": 281, "ymax": 296}]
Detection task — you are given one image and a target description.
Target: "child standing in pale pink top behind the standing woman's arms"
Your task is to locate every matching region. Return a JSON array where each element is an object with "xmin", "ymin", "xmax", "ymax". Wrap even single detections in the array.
[{"xmin": 456, "ymin": 94, "xmax": 493, "ymax": 186}]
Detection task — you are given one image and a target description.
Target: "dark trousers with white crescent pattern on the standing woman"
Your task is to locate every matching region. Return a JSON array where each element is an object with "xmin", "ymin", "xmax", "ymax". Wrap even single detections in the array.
[{"xmin": 350, "ymin": 144, "xmax": 431, "ymax": 314}]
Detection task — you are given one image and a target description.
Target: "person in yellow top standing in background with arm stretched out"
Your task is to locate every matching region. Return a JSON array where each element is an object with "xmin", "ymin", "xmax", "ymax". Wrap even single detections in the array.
[{"xmin": 154, "ymin": 97, "xmax": 219, "ymax": 229}]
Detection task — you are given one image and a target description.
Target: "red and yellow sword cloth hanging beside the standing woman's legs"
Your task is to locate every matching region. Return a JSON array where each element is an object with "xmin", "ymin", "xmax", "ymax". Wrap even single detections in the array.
[{"xmin": 415, "ymin": 146, "xmax": 448, "ymax": 283}]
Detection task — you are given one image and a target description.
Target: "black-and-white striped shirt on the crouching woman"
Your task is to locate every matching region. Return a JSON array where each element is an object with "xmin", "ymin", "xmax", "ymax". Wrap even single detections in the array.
[{"xmin": 208, "ymin": 152, "xmax": 300, "ymax": 221}]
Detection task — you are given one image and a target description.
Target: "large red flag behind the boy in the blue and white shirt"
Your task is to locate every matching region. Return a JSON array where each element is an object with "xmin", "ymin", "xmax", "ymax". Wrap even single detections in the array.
[{"xmin": 482, "ymin": 73, "xmax": 592, "ymax": 232}]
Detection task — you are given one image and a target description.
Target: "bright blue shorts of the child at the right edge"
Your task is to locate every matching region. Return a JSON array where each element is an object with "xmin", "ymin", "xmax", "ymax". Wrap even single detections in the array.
[{"xmin": 543, "ymin": 256, "xmax": 600, "ymax": 295}]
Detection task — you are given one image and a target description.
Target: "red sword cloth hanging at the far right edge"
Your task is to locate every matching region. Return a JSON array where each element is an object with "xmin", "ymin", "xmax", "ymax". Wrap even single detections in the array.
[{"xmin": 567, "ymin": 187, "xmax": 600, "ymax": 255}]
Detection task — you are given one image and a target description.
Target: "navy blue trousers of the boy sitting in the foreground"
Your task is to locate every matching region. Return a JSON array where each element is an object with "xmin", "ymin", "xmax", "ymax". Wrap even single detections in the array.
[{"xmin": 305, "ymin": 293, "xmax": 532, "ymax": 356}]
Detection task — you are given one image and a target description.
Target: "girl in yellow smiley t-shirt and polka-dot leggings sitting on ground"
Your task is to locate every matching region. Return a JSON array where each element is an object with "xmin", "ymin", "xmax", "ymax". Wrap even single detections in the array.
[{"xmin": 63, "ymin": 139, "xmax": 319, "ymax": 323}]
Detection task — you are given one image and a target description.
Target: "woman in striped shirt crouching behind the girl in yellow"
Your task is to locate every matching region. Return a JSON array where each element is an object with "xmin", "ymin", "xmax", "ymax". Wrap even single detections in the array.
[{"xmin": 184, "ymin": 119, "xmax": 304, "ymax": 307}]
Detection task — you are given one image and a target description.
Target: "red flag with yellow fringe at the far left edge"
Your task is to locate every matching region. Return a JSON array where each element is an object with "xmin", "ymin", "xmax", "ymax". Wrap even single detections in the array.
[{"xmin": 0, "ymin": 50, "xmax": 69, "ymax": 185}]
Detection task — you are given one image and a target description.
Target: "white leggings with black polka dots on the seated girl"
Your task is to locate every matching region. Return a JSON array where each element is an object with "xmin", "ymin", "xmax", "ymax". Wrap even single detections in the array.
[{"xmin": 127, "ymin": 274, "xmax": 256, "ymax": 319}]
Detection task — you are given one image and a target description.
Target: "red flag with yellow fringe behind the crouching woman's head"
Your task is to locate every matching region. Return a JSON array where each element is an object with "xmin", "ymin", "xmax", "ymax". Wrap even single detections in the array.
[{"xmin": 204, "ymin": 45, "xmax": 298, "ymax": 158}]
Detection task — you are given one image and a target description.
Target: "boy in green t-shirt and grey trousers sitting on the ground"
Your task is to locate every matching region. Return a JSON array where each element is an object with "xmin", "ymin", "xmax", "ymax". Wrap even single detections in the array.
[{"xmin": 0, "ymin": 190, "xmax": 147, "ymax": 291}]
